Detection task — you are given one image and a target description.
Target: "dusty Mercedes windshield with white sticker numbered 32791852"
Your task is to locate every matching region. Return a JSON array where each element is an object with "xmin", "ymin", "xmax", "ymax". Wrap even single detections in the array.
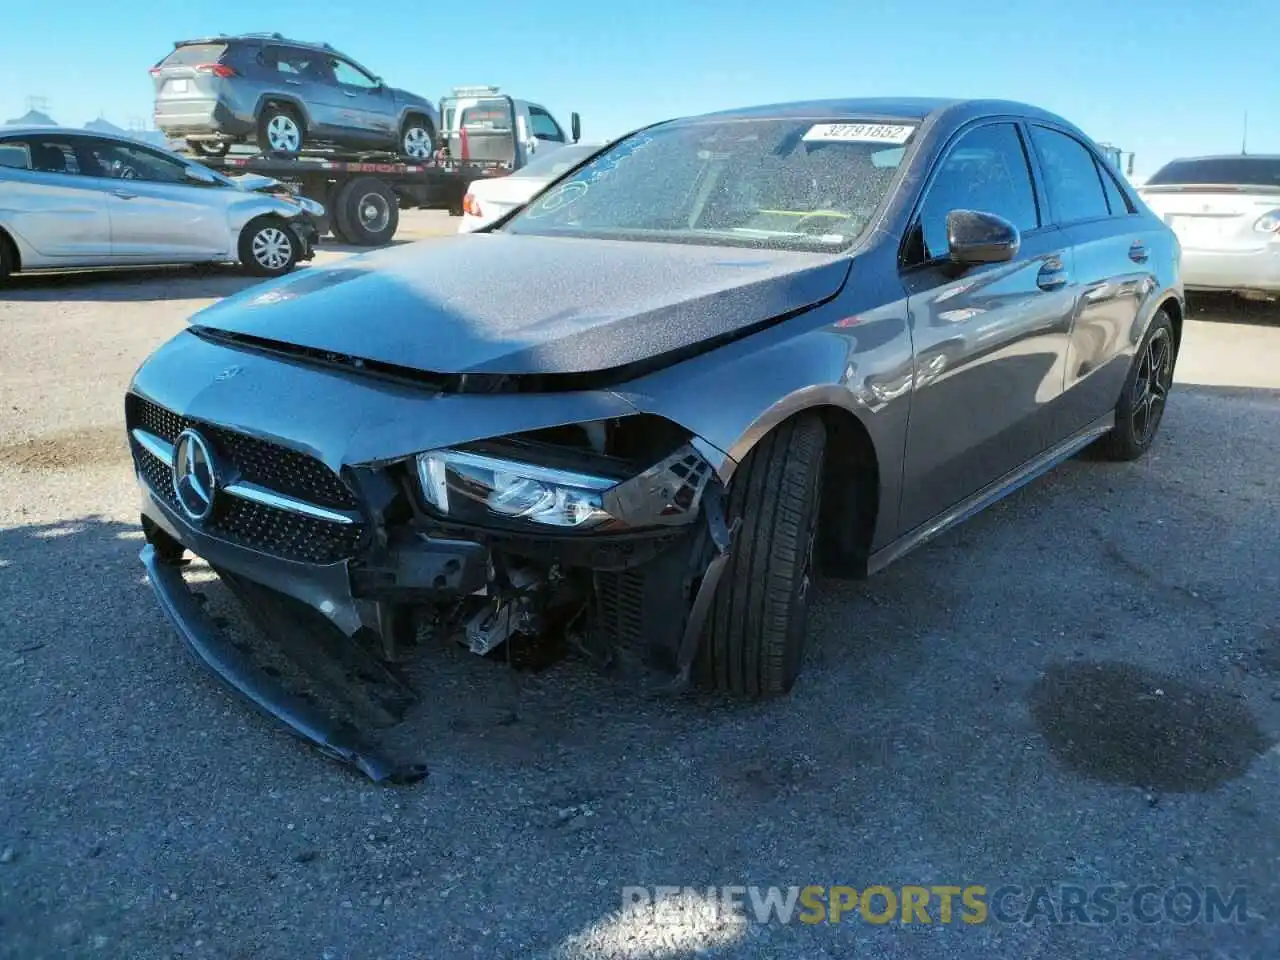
[{"xmin": 502, "ymin": 119, "xmax": 914, "ymax": 251}]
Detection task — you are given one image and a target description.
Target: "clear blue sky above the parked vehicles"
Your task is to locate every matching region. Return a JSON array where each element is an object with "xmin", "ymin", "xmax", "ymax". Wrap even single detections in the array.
[{"xmin": 0, "ymin": 0, "xmax": 1280, "ymax": 175}]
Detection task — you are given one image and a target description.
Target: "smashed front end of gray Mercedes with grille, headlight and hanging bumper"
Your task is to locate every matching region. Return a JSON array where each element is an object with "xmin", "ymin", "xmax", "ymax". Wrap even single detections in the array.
[{"xmin": 125, "ymin": 393, "xmax": 731, "ymax": 782}]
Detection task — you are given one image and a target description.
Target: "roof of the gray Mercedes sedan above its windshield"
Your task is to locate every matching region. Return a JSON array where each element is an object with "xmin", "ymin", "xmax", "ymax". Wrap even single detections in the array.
[{"xmin": 682, "ymin": 97, "xmax": 1073, "ymax": 127}]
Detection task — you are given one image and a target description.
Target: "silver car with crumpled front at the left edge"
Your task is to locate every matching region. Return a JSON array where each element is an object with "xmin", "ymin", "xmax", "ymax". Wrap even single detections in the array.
[{"xmin": 0, "ymin": 127, "xmax": 324, "ymax": 279}]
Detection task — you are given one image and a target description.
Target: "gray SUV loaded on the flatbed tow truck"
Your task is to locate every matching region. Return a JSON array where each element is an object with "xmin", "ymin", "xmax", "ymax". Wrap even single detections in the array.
[{"xmin": 151, "ymin": 33, "xmax": 439, "ymax": 160}]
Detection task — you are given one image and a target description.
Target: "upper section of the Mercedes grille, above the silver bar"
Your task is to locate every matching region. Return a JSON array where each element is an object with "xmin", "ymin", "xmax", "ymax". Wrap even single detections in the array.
[{"xmin": 124, "ymin": 393, "xmax": 356, "ymax": 509}]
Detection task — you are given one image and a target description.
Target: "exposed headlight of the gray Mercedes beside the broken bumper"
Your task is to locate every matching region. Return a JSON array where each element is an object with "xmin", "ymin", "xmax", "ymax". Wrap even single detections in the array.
[{"xmin": 417, "ymin": 444, "xmax": 714, "ymax": 532}]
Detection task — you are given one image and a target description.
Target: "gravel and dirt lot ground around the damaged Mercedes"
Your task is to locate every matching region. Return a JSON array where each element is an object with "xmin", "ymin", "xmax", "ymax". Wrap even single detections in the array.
[{"xmin": 0, "ymin": 216, "xmax": 1280, "ymax": 960}]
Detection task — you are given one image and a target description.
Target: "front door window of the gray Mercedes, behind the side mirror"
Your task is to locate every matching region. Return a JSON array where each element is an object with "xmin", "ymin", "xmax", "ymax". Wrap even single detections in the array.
[{"xmin": 920, "ymin": 123, "xmax": 1039, "ymax": 260}]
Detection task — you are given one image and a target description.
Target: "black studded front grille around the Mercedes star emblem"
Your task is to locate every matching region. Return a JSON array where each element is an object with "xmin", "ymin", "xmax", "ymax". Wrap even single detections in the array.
[{"xmin": 125, "ymin": 394, "xmax": 365, "ymax": 563}]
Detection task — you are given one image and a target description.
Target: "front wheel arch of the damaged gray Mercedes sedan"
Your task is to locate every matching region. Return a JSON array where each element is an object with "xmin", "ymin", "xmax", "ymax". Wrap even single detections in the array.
[{"xmin": 721, "ymin": 387, "xmax": 884, "ymax": 580}]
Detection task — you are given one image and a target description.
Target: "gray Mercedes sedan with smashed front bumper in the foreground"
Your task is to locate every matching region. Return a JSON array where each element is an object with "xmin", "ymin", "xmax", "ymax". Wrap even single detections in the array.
[{"xmin": 125, "ymin": 100, "xmax": 1183, "ymax": 781}]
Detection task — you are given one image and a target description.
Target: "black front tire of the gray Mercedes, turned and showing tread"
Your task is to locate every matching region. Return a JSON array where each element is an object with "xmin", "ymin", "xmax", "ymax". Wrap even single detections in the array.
[{"xmin": 696, "ymin": 415, "xmax": 827, "ymax": 698}]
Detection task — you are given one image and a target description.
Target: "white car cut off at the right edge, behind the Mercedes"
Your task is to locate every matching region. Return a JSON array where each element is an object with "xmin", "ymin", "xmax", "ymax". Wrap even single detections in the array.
[{"xmin": 1139, "ymin": 155, "xmax": 1280, "ymax": 300}]
